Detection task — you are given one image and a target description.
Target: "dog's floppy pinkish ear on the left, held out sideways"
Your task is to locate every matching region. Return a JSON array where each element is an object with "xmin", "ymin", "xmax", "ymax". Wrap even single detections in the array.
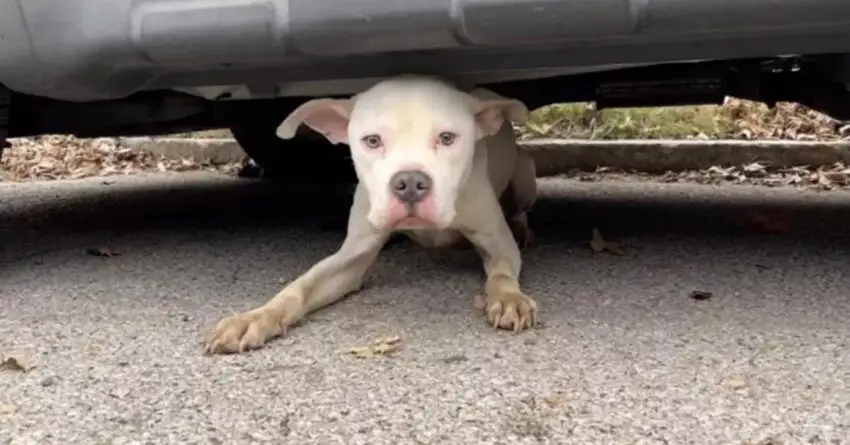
[{"xmin": 277, "ymin": 99, "xmax": 354, "ymax": 144}]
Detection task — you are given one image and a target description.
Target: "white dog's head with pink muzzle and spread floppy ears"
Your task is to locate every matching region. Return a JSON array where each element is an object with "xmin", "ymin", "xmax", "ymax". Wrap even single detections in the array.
[{"xmin": 277, "ymin": 76, "xmax": 528, "ymax": 230}]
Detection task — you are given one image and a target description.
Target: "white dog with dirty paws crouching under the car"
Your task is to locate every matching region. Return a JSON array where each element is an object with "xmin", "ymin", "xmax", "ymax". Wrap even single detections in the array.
[{"xmin": 204, "ymin": 76, "xmax": 538, "ymax": 353}]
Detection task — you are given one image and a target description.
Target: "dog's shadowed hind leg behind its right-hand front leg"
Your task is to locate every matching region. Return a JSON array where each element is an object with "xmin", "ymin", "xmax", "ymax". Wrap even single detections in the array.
[{"xmin": 505, "ymin": 149, "xmax": 537, "ymax": 247}]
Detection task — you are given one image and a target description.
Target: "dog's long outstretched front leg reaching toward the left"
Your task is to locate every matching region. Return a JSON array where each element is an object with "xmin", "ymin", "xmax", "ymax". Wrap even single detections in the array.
[{"xmin": 204, "ymin": 185, "xmax": 390, "ymax": 353}]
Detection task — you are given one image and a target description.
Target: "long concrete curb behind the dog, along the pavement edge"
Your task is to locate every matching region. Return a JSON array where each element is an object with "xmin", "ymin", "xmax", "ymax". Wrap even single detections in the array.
[{"xmin": 119, "ymin": 138, "xmax": 850, "ymax": 176}]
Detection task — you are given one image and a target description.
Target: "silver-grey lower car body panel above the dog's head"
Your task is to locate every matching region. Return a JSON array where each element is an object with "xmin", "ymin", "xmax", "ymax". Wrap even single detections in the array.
[{"xmin": 0, "ymin": 0, "xmax": 850, "ymax": 101}]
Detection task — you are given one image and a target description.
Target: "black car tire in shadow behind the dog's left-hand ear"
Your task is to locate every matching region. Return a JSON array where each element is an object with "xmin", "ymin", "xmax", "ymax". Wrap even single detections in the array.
[{"xmin": 225, "ymin": 115, "xmax": 357, "ymax": 184}]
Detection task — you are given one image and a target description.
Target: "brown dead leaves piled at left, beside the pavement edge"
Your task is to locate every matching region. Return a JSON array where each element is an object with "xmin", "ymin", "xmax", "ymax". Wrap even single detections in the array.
[{"xmin": 0, "ymin": 135, "xmax": 239, "ymax": 181}]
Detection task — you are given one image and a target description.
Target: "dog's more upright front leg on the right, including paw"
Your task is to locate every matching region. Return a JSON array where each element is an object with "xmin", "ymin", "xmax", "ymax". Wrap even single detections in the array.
[{"xmin": 464, "ymin": 186, "xmax": 537, "ymax": 332}]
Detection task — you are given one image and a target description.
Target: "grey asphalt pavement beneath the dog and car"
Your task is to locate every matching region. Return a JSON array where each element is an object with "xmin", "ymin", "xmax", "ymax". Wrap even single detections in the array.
[{"xmin": 0, "ymin": 173, "xmax": 850, "ymax": 445}]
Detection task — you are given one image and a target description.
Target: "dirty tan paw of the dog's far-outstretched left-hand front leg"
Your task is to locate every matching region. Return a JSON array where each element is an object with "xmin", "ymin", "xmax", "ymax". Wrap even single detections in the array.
[{"xmin": 204, "ymin": 308, "xmax": 286, "ymax": 354}]
